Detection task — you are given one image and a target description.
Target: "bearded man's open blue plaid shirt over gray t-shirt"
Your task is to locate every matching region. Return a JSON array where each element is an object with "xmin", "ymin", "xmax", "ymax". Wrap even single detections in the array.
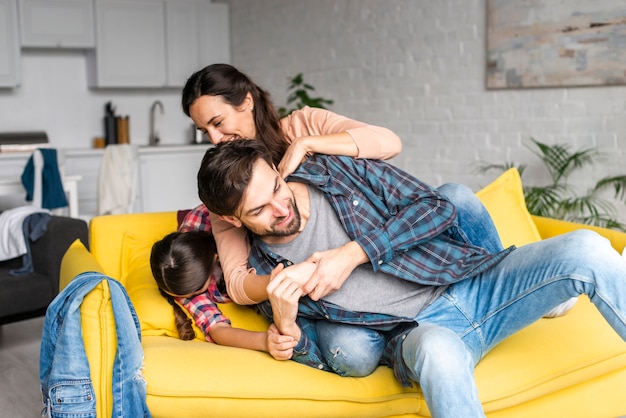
[{"xmin": 250, "ymin": 155, "xmax": 513, "ymax": 384}]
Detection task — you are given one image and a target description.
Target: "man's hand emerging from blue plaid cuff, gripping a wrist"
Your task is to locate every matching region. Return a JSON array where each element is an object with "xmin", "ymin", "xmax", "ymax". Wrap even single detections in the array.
[{"xmin": 302, "ymin": 241, "xmax": 368, "ymax": 300}]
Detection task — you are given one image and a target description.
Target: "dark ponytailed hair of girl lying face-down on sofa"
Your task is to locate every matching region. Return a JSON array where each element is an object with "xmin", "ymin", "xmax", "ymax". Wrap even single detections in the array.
[{"xmin": 150, "ymin": 231, "xmax": 220, "ymax": 340}]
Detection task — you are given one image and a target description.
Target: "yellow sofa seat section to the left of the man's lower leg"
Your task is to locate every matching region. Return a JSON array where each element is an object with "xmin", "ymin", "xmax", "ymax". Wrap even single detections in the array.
[{"xmin": 143, "ymin": 337, "xmax": 423, "ymax": 418}]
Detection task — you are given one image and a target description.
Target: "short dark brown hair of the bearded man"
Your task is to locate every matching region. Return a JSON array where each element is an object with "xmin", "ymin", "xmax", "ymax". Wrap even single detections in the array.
[{"xmin": 198, "ymin": 139, "xmax": 273, "ymax": 216}]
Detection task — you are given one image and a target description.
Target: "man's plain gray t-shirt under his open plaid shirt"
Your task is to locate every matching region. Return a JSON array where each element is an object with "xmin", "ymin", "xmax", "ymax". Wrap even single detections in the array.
[{"xmin": 269, "ymin": 187, "xmax": 446, "ymax": 318}]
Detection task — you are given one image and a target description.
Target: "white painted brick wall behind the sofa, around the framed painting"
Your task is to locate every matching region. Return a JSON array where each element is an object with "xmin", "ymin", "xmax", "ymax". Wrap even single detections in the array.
[{"xmin": 229, "ymin": 0, "xmax": 626, "ymax": 220}]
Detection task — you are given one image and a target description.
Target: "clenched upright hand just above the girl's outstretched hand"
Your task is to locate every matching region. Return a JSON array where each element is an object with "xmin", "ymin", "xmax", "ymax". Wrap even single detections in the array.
[{"xmin": 267, "ymin": 264, "xmax": 302, "ymax": 341}]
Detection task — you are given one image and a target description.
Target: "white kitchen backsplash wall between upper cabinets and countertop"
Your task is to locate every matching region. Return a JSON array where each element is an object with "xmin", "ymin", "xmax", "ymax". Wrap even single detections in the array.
[{"xmin": 0, "ymin": 50, "xmax": 191, "ymax": 148}]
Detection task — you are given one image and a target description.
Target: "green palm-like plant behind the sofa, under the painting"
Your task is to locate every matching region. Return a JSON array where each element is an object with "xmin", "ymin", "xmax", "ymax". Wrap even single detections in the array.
[{"xmin": 479, "ymin": 138, "xmax": 626, "ymax": 231}]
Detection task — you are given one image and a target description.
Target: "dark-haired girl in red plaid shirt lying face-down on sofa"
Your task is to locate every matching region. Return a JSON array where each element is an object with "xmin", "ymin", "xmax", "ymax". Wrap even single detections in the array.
[{"xmin": 150, "ymin": 231, "xmax": 297, "ymax": 359}]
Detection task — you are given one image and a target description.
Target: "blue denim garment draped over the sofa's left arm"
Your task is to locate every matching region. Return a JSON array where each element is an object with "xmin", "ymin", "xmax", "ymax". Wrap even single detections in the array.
[{"xmin": 39, "ymin": 272, "xmax": 151, "ymax": 418}]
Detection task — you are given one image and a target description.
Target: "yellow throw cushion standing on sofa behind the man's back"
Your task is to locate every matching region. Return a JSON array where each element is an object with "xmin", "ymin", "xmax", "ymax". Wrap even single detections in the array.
[{"xmin": 476, "ymin": 168, "xmax": 541, "ymax": 248}]
